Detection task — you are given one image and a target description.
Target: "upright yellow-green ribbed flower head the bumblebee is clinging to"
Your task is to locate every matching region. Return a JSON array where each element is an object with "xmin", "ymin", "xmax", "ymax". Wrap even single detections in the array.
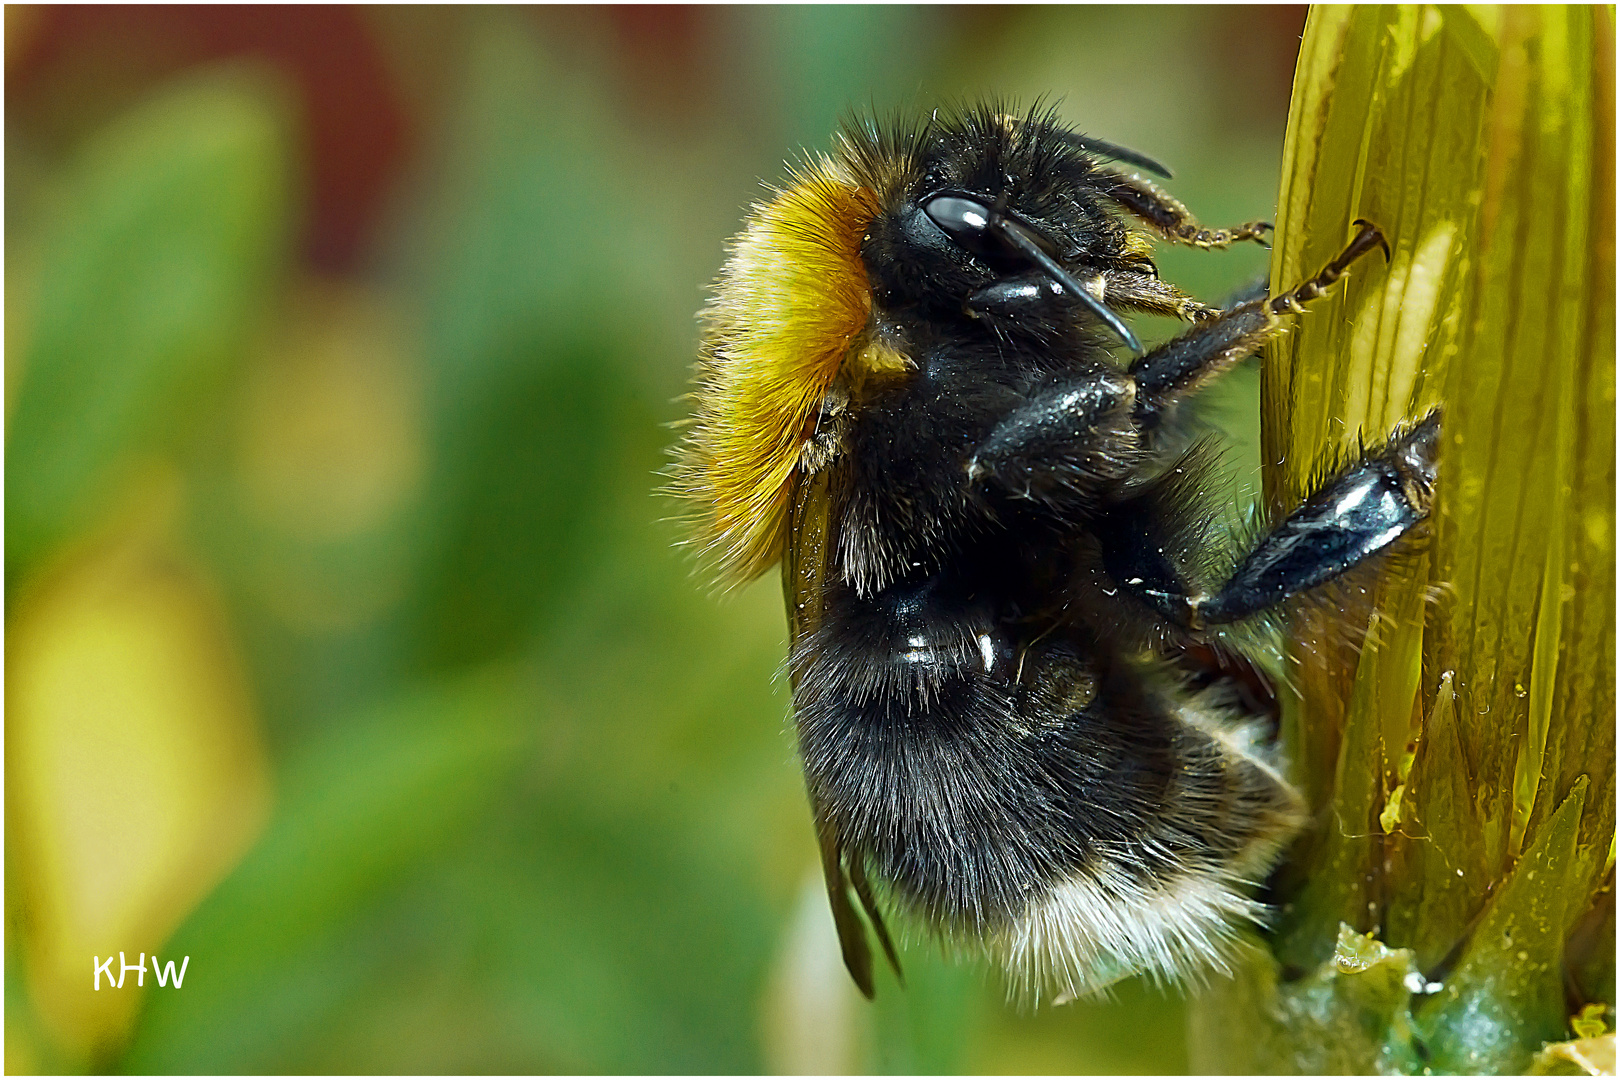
[{"xmin": 1192, "ymin": 6, "xmax": 1615, "ymax": 1074}]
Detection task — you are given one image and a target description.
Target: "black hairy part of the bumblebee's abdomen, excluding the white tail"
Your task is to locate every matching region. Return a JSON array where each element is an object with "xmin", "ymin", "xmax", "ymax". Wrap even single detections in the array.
[{"xmin": 794, "ymin": 528, "xmax": 1275, "ymax": 933}]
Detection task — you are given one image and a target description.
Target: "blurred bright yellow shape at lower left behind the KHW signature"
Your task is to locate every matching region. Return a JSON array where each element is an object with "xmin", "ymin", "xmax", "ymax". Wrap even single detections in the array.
[{"xmin": 6, "ymin": 483, "xmax": 271, "ymax": 1064}]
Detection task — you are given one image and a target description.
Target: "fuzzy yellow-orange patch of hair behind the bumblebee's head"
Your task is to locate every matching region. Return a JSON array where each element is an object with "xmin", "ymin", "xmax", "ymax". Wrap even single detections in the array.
[{"xmin": 674, "ymin": 157, "xmax": 880, "ymax": 585}]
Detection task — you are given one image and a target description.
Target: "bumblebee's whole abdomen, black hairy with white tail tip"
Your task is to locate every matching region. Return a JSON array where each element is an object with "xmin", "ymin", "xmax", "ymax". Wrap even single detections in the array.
[{"xmin": 795, "ymin": 569, "xmax": 1301, "ymax": 994}]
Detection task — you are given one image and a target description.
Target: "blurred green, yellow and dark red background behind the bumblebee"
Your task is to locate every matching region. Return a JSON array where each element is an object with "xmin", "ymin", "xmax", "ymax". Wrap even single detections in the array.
[{"xmin": 5, "ymin": 6, "xmax": 1304, "ymax": 1074}]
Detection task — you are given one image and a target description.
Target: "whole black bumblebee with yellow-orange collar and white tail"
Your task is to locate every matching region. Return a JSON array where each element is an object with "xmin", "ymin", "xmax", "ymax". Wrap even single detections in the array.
[{"xmin": 674, "ymin": 104, "xmax": 1439, "ymax": 997}]
